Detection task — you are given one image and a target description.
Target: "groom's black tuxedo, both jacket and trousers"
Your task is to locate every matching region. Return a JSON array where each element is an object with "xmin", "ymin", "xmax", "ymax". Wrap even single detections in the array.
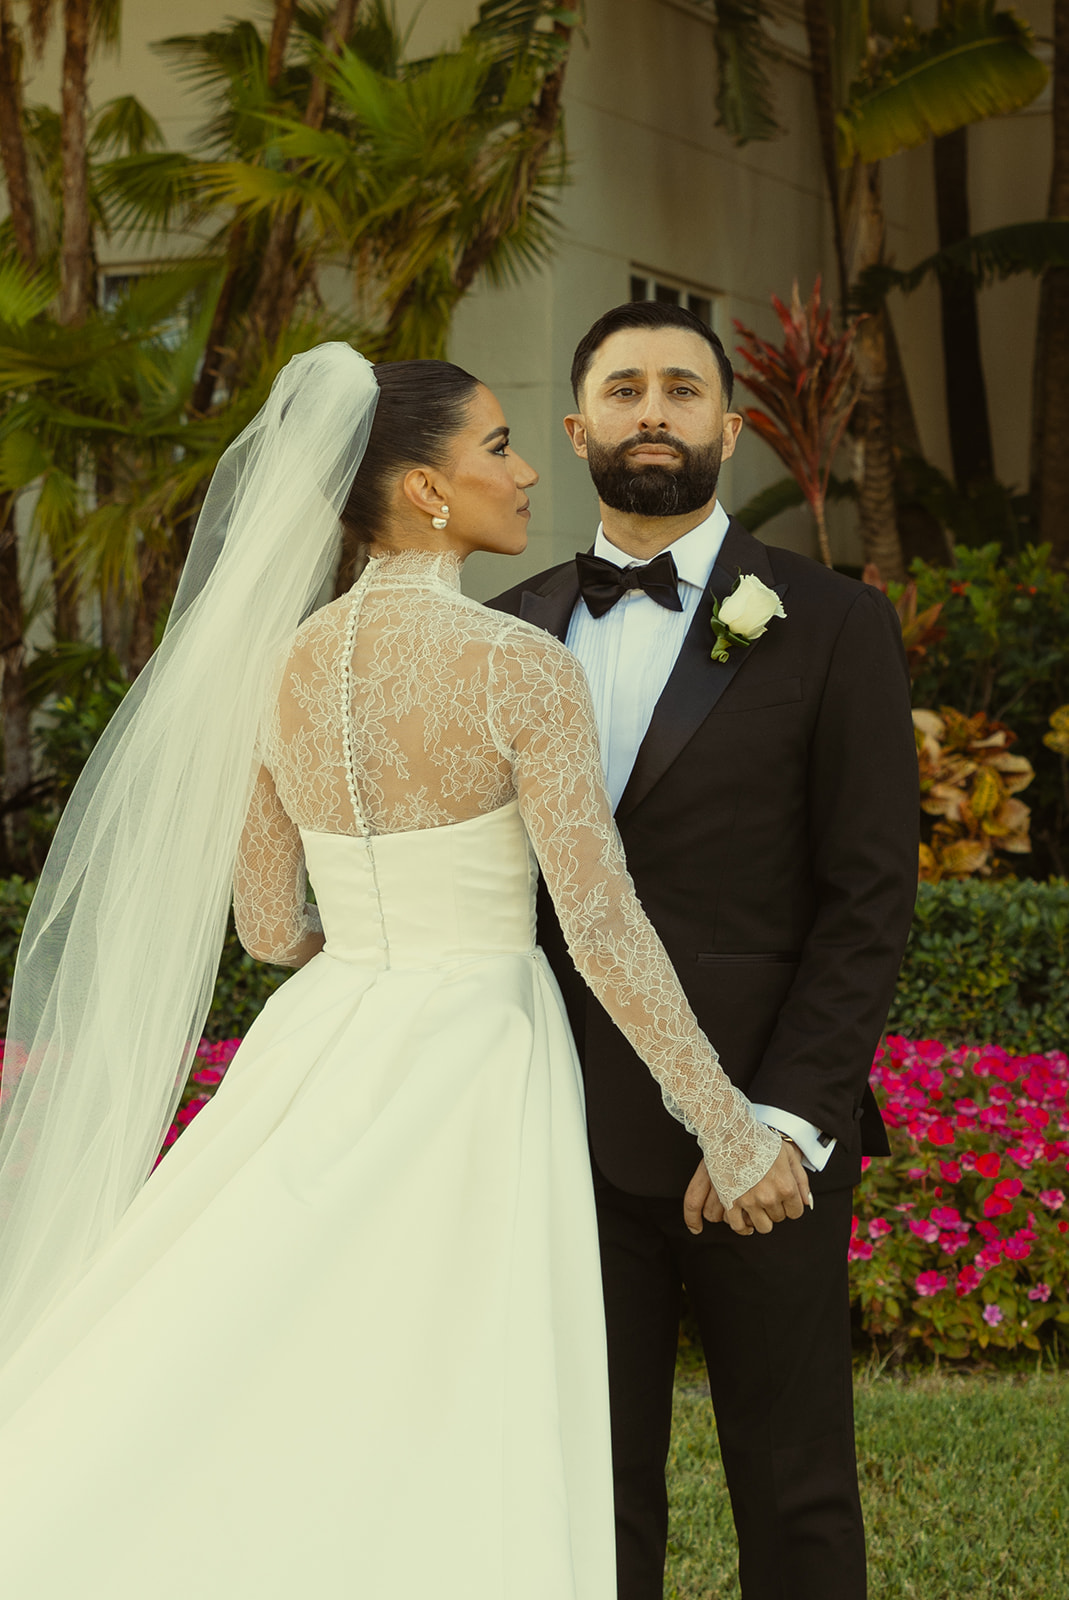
[{"xmin": 491, "ymin": 520, "xmax": 919, "ymax": 1600}]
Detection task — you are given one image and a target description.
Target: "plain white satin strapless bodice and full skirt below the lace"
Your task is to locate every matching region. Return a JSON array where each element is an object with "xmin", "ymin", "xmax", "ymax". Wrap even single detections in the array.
[{"xmin": 0, "ymin": 806, "xmax": 616, "ymax": 1600}]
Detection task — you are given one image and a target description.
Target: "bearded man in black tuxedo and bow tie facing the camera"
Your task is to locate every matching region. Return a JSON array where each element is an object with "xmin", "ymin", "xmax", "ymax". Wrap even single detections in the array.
[{"xmin": 493, "ymin": 302, "xmax": 919, "ymax": 1600}]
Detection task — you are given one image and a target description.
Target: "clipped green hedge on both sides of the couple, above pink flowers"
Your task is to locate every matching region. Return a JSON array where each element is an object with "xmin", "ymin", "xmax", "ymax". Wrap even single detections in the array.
[{"xmin": 0, "ymin": 878, "xmax": 1069, "ymax": 1054}]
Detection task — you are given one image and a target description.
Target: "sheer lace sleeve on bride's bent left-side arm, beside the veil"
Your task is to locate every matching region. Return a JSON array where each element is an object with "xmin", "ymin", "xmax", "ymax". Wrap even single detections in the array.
[{"xmin": 234, "ymin": 766, "xmax": 323, "ymax": 966}]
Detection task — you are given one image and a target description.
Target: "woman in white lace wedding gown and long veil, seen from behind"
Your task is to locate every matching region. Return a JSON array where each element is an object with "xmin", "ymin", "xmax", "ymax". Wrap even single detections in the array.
[{"xmin": 0, "ymin": 344, "xmax": 800, "ymax": 1600}]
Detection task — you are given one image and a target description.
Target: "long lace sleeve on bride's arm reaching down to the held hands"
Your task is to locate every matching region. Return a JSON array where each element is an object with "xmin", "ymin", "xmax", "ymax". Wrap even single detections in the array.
[{"xmin": 490, "ymin": 630, "xmax": 781, "ymax": 1206}]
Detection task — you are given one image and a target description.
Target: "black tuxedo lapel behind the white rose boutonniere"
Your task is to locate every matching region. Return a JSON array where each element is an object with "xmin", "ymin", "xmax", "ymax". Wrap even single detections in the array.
[{"xmin": 616, "ymin": 518, "xmax": 786, "ymax": 819}]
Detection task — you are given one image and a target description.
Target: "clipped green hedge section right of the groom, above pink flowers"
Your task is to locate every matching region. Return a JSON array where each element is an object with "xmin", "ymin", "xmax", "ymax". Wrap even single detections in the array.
[{"xmin": 888, "ymin": 878, "xmax": 1069, "ymax": 1054}]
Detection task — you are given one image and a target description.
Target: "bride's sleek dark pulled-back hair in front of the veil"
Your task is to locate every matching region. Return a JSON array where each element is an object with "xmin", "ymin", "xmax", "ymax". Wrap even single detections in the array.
[{"xmin": 341, "ymin": 362, "xmax": 478, "ymax": 544}]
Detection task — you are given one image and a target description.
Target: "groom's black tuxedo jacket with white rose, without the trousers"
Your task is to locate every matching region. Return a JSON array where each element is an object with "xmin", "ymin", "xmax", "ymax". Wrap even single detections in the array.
[{"xmin": 491, "ymin": 518, "xmax": 920, "ymax": 1195}]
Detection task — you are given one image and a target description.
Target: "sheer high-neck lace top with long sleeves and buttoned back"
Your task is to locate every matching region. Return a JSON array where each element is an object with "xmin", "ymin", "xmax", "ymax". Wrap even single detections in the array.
[{"xmin": 234, "ymin": 554, "xmax": 779, "ymax": 1203}]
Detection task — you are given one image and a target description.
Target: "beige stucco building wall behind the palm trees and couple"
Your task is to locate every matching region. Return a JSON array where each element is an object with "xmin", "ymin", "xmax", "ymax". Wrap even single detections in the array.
[{"xmin": 16, "ymin": 0, "xmax": 1050, "ymax": 595}]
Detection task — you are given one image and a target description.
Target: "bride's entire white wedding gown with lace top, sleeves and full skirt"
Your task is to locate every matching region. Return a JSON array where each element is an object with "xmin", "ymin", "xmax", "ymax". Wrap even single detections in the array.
[{"xmin": 0, "ymin": 557, "xmax": 779, "ymax": 1600}]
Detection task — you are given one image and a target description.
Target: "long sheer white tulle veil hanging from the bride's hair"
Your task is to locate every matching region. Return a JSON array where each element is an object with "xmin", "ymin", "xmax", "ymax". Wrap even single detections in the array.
[{"xmin": 0, "ymin": 344, "xmax": 378, "ymax": 1362}]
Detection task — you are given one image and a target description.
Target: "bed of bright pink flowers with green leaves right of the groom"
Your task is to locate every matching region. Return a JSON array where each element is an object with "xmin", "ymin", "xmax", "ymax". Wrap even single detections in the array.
[{"xmin": 850, "ymin": 1035, "xmax": 1069, "ymax": 1357}]
